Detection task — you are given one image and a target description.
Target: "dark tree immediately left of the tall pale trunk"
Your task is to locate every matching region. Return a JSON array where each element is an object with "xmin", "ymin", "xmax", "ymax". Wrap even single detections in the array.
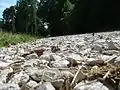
[{"xmin": 16, "ymin": 0, "xmax": 33, "ymax": 33}]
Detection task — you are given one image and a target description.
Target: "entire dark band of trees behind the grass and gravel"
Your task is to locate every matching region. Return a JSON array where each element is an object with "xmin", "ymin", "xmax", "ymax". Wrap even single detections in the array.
[{"xmin": 2, "ymin": 0, "xmax": 120, "ymax": 36}]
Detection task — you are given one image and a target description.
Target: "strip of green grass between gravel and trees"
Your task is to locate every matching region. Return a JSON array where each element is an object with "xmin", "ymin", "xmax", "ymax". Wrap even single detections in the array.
[{"xmin": 0, "ymin": 32, "xmax": 40, "ymax": 47}]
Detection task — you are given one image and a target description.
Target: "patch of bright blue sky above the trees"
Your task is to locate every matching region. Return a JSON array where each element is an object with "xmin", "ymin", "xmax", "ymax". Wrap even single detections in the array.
[{"xmin": 0, "ymin": 0, "xmax": 17, "ymax": 18}]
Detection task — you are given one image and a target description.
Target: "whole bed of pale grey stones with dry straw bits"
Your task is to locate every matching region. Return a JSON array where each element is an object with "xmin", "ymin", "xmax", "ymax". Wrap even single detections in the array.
[{"xmin": 0, "ymin": 31, "xmax": 120, "ymax": 90}]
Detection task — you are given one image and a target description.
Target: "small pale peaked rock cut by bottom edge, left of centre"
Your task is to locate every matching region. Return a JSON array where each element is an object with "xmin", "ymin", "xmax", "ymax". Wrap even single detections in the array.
[{"xmin": 36, "ymin": 82, "xmax": 55, "ymax": 90}]
